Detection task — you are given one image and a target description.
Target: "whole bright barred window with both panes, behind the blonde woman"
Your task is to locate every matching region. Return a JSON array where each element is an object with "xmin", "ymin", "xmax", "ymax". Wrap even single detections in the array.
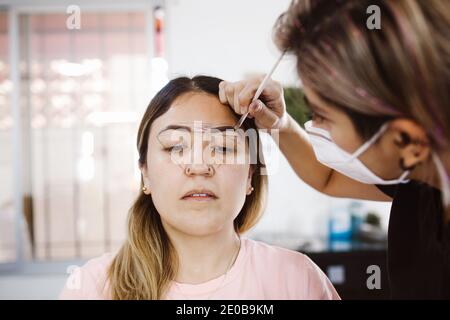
[{"xmin": 0, "ymin": 1, "xmax": 167, "ymax": 264}]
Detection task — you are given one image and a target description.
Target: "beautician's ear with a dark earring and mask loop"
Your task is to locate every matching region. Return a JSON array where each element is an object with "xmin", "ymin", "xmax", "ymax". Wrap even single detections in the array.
[{"xmin": 390, "ymin": 119, "xmax": 431, "ymax": 170}]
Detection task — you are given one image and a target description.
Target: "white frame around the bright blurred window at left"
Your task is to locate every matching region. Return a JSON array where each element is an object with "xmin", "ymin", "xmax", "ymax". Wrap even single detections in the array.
[{"xmin": 0, "ymin": 0, "xmax": 162, "ymax": 275}]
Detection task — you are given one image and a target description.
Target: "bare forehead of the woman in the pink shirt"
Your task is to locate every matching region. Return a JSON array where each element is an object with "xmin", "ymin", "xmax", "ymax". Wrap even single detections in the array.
[{"xmin": 152, "ymin": 92, "xmax": 237, "ymax": 132}]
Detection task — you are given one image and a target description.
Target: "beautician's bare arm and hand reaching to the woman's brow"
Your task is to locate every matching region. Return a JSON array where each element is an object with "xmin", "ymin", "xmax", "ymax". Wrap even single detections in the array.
[{"xmin": 219, "ymin": 78, "xmax": 392, "ymax": 201}]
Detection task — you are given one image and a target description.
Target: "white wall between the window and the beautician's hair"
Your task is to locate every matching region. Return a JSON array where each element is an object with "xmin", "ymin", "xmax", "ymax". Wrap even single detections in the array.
[{"xmin": 166, "ymin": 0, "xmax": 296, "ymax": 83}]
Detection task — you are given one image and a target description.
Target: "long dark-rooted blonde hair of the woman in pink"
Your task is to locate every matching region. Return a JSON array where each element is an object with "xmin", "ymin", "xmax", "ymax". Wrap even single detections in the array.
[{"xmin": 108, "ymin": 76, "xmax": 267, "ymax": 300}]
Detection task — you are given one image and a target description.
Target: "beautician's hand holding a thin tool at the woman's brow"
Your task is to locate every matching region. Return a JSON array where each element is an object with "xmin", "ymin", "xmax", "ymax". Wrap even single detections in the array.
[{"xmin": 219, "ymin": 77, "xmax": 288, "ymax": 130}]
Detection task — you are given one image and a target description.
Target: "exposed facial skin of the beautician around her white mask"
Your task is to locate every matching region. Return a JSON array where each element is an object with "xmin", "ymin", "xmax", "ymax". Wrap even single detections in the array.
[{"xmin": 304, "ymin": 87, "xmax": 403, "ymax": 180}]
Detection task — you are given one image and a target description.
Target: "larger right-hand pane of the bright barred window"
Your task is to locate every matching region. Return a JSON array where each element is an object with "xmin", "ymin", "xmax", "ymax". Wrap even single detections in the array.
[{"xmin": 25, "ymin": 13, "xmax": 150, "ymax": 260}]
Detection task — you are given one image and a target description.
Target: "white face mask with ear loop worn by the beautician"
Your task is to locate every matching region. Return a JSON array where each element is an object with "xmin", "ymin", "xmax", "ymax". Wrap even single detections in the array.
[{"xmin": 305, "ymin": 121, "xmax": 410, "ymax": 185}]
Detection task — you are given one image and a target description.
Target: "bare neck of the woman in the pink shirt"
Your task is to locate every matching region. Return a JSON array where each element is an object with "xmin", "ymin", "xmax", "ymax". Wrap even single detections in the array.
[{"xmin": 164, "ymin": 225, "xmax": 240, "ymax": 284}]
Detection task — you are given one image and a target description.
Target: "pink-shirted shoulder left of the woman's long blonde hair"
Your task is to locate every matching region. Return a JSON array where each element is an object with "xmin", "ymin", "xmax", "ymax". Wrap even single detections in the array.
[{"xmin": 59, "ymin": 253, "xmax": 114, "ymax": 300}]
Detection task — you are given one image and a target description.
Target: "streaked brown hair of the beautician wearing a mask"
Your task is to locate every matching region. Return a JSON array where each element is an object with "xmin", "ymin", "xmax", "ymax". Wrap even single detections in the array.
[{"xmin": 274, "ymin": 0, "xmax": 450, "ymax": 145}]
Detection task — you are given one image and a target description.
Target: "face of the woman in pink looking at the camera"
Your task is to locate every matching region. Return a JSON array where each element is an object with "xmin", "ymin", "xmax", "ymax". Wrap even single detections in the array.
[{"xmin": 141, "ymin": 92, "xmax": 251, "ymax": 236}]
